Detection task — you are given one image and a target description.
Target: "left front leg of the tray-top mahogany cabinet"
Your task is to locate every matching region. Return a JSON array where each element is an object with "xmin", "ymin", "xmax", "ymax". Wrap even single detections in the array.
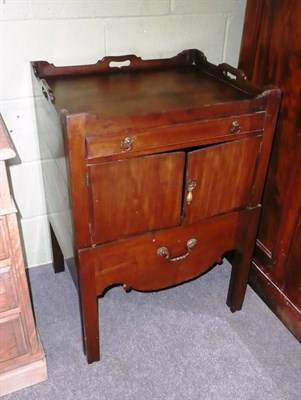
[{"xmin": 78, "ymin": 253, "xmax": 100, "ymax": 364}]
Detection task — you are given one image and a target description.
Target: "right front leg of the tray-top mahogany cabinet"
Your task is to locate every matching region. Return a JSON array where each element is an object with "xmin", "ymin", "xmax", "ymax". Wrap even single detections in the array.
[{"xmin": 227, "ymin": 207, "xmax": 260, "ymax": 312}]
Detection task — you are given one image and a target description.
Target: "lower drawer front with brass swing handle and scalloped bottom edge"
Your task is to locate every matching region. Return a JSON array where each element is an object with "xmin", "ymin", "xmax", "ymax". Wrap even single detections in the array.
[{"xmin": 79, "ymin": 211, "xmax": 248, "ymax": 295}]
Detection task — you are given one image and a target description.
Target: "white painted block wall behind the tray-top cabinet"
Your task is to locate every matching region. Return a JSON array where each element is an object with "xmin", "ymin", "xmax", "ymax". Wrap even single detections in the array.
[{"xmin": 0, "ymin": 0, "xmax": 246, "ymax": 267}]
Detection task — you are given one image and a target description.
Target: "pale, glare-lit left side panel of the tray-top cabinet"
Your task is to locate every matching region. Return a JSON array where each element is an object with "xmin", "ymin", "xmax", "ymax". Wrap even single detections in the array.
[{"xmin": 32, "ymin": 69, "xmax": 73, "ymax": 258}]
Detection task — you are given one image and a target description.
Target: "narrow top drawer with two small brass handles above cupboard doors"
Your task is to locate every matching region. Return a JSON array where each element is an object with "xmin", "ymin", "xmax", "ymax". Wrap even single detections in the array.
[{"xmin": 86, "ymin": 112, "xmax": 265, "ymax": 160}]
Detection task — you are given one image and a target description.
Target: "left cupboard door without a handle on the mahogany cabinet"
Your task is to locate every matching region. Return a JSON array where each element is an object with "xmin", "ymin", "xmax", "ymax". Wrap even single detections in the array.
[{"xmin": 88, "ymin": 152, "xmax": 185, "ymax": 244}]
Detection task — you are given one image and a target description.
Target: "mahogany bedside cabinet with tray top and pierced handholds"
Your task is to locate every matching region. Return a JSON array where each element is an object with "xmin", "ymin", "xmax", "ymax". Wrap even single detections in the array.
[{"xmin": 32, "ymin": 50, "xmax": 280, "ymax": 363}]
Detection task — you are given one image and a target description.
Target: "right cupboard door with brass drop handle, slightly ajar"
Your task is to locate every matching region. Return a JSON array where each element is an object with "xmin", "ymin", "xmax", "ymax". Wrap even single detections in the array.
[{"xmin": 184, "ymin": 136, "xmax": 261, "ymax": 224}]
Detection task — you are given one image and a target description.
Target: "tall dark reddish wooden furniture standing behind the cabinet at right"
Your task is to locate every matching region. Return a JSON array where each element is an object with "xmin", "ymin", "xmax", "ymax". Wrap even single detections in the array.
[{"xmin": 239, "ymin": 0, "xmax": 301, "ymax": 340}]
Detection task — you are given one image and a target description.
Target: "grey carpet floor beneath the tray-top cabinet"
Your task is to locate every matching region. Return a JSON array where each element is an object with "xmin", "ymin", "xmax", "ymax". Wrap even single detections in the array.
[{"xmin": 4, "ymin": 262, "xmax": 301, "ymax": 400}]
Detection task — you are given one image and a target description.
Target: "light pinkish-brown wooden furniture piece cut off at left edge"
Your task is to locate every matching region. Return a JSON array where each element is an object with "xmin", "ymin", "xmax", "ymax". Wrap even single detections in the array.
[{"xmin": 0, "ymin": 115, "xmax": 47, "ymax": 396}]
